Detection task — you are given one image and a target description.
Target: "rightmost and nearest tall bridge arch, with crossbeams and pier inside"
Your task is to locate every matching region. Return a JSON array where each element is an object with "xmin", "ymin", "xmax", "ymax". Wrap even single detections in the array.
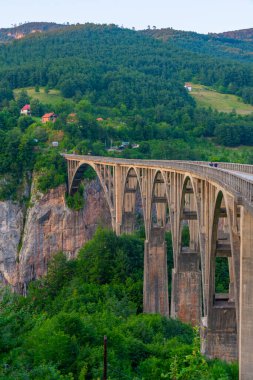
[{"xmin": 205, "ymin": 188, "xmax": 238, "ymax": 361}]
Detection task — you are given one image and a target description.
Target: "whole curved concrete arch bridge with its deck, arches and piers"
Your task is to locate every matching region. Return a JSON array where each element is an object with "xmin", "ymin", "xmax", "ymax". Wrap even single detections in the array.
[{"xmin": 63, "ymin": 154, "xmax": 253, "ymax": 380}]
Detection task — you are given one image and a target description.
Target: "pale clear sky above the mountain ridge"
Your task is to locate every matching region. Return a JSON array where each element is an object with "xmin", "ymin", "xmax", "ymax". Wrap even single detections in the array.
[{"xmin": 0, "ymin": 0, "xmax": 253, "ymax": 33}]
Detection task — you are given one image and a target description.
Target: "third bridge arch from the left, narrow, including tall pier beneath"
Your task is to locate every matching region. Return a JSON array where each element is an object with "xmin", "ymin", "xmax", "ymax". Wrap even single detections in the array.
[{"xmin": 143, "ymin": 170, "xmax": 169, "ymax": 316}]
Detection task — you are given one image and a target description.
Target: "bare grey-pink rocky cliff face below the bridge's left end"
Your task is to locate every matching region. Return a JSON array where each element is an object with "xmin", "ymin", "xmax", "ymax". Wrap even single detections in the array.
[{"xmin": 0, "ymin": 181, "xmax": 111, "ymax": 292}]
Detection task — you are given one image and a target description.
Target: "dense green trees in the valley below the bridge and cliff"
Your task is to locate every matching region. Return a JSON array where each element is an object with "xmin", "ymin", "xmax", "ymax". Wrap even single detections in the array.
[{"xmin": 0, "ymin": 229, "xmax": 238, "ymax": 380}]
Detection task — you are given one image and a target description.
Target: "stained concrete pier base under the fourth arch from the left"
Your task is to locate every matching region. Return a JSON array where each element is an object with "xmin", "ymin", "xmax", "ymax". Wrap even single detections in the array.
[{"xmin": 171, "ymin": 252, "xmax": 201, "ymax": 326}]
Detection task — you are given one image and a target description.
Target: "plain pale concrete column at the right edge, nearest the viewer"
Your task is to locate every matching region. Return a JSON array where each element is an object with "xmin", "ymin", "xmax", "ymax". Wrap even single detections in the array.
[{"xmin": 239, "ymin": 208, "xmax": 253, "ymax": 380}]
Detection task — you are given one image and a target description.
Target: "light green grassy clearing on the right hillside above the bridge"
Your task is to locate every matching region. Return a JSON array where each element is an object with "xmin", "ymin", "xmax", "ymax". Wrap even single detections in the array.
[{"xmin": 191, "ymin": 84, "xmax": 253, "ymax": 115}]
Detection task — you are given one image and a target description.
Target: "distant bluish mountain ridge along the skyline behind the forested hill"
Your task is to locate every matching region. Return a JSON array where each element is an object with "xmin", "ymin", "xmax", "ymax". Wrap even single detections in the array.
[{"xmin": 0, "ymin": 22, "xmax": 253, "ymax": 62}]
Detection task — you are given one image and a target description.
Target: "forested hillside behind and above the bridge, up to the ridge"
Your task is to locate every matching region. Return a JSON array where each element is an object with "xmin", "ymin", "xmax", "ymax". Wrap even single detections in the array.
[{"xmin": 0, "ymin": 24, "xmax": 253, "ymax": 199}]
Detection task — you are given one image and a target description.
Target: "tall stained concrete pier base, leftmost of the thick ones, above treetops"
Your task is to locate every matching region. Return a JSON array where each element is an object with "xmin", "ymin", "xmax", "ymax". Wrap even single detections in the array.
[{"xmin": 143, "ymin": 228, "xmax": 169, "ymax": 316}]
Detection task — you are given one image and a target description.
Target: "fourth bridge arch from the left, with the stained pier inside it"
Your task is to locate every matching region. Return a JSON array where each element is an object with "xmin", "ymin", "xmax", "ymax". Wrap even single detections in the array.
[{"xmin": 171, "ymin": 175, "xmax": 204, "ymax": 325}]
